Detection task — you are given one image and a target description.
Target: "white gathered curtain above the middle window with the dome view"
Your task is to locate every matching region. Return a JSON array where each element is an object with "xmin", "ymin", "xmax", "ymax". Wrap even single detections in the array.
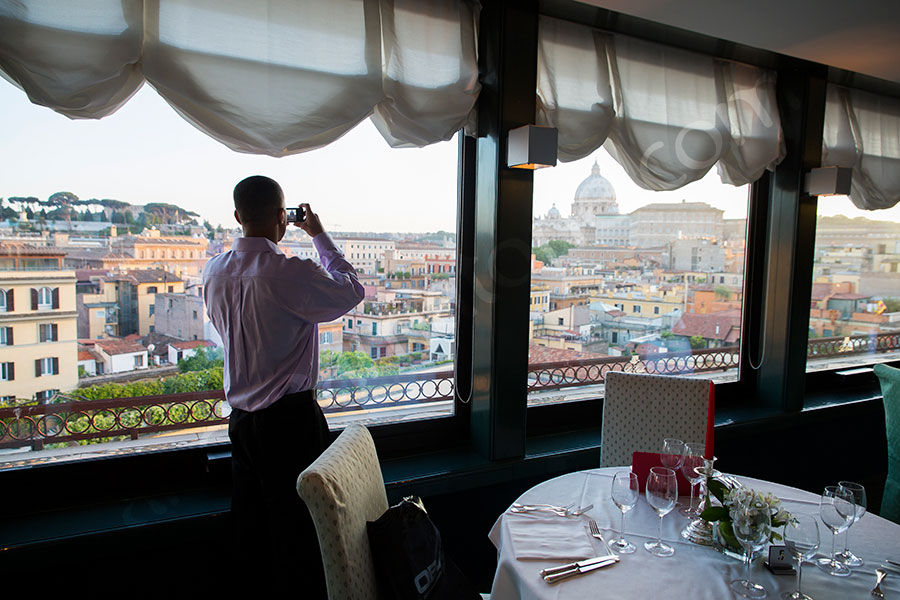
[{"xmin": 537, "ymin": 17, "xmax": 784, "ymax": 190}]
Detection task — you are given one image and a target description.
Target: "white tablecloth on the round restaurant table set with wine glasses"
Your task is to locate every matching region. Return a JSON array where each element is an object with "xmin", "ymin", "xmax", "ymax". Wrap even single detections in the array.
[{"xmin": 489, "ymin": 467, "xmax": 900, "ymax": 600}]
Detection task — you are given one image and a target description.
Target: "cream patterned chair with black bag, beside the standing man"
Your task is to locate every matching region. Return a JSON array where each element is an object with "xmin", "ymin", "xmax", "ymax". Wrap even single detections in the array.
[{"xmin": 297, "ymin": 425, "xmax": 388, "ymax": 600}]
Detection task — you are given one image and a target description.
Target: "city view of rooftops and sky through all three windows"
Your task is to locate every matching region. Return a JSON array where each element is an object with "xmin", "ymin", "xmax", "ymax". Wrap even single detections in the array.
[{"xmin": 0, "ymin": 78, "xmax": 900, "ymax": 464}]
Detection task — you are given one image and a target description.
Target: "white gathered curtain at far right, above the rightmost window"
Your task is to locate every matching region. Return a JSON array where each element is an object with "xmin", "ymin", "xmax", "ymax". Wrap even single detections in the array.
[{"xmin": 822, "ymin": 84, "xmax": 900, "ymax": 210}]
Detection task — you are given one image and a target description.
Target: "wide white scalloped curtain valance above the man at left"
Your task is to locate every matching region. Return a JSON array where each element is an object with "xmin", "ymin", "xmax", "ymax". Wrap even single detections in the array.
[{"xmin": 0, "ymin": 0, "xmax": 480, "ymax": 156}]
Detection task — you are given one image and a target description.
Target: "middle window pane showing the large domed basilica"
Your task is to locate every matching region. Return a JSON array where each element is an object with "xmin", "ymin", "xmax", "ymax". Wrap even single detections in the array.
[{"xmin": 528, "ymin": 149, "xmax": 749, "ymax": 405}]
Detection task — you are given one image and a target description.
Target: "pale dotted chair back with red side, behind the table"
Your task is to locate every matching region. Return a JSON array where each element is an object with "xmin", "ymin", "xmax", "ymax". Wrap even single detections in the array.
[{"xmin": 600, "ymin": 371, "xmax": 712, "ymax": 467}]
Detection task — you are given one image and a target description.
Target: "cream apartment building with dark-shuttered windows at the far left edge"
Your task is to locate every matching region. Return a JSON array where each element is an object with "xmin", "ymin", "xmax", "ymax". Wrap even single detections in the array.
[{"xmin": 0, "ymin": 245, "xmax": 78, "ymax": 404}]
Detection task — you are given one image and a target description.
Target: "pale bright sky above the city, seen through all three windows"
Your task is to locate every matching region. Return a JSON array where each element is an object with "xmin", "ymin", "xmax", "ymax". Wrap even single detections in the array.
[{"xmin": 0, "ymin": 80, "xmax": 900, "ymax": 232}]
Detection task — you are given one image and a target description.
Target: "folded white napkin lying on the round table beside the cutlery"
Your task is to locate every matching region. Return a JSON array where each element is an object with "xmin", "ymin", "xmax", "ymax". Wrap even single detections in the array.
[{"xmin": 505, "ymin": 511, "xmax": 596, "ymax": 561}]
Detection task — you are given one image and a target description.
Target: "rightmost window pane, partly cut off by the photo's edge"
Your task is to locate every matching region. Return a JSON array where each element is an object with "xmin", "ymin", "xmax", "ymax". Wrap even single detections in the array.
[{"xmin": 806, "ymin": 196, "xmax": 900, "ymax": 371}]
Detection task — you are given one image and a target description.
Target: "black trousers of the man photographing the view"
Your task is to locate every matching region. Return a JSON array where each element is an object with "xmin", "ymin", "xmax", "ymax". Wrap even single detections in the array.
[{"xmin": 228, "ymin": 390, "xmax": 330, "ymax": 599}]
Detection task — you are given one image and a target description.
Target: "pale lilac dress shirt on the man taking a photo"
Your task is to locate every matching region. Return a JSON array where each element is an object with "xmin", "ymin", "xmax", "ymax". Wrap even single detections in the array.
[{"xmin": 203, "ymin": 233, "xmax": 365, "ymax": 412}]
